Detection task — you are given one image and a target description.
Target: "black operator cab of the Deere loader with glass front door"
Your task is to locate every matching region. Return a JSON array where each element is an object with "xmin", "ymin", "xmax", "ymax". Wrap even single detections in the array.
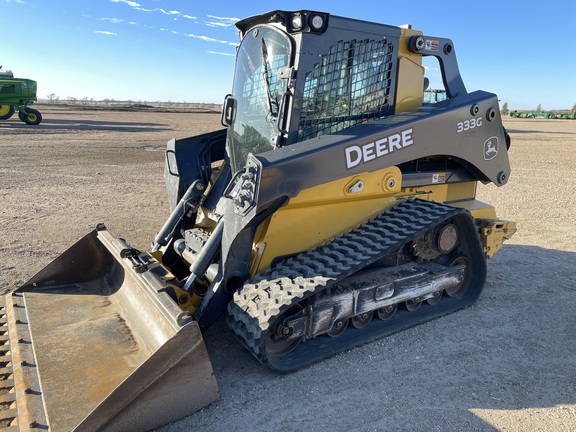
[{"xmin": 222, "ymin": 11, "xmax": 401, "ymax": 172}]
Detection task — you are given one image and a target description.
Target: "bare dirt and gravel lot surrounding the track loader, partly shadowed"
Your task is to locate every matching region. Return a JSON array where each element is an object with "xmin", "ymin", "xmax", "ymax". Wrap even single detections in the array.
[{"xmin": 0, "ymin": 107, "xmax": 576, "ymax": 431}]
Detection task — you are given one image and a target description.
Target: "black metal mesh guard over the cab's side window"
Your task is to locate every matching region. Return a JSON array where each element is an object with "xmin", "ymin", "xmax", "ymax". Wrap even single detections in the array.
[{"xmin": 298, "ymin": 39, "xmax": 396, "ymax": 141}]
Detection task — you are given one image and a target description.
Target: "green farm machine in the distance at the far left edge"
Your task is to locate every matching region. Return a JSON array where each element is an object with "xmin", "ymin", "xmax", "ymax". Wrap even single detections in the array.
[{"xmin": 0, "ymin": 66, "xmax": 42, "ymax": 125}]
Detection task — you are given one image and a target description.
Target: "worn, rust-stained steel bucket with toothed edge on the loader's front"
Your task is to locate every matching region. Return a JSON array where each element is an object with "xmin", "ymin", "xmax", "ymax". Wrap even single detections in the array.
[{"xmin": 0, "ymin": 225, "xmax": 219, "ymax": 431}]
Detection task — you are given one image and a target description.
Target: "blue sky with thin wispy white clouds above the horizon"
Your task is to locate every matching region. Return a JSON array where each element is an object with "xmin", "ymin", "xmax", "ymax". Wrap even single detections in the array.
[{"xmin": 0, "ymin": 0, "xmax": 576, "ymax": 110}]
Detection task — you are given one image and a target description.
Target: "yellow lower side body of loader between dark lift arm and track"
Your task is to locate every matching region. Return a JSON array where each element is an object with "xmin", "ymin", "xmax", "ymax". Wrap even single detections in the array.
[{"xmin": 250, "ymin": 172, "xmax": 503, "ymax": 277}]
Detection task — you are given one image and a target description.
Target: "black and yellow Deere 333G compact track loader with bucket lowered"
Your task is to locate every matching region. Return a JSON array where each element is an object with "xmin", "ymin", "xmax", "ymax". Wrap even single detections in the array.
[{"xmin": 0, "ymin": 11, "xmax": 515, "ymax": 431}]
